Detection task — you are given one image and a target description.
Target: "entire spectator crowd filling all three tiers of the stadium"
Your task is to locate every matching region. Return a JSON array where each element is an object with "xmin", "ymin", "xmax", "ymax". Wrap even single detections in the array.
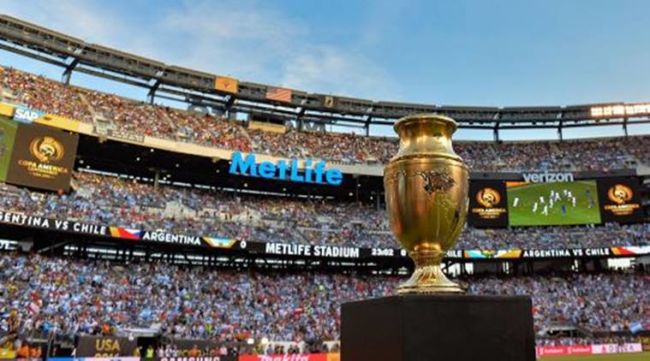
[{"xmin": 0, "ymin": 64, "xmax": 650, "ymax": 354}]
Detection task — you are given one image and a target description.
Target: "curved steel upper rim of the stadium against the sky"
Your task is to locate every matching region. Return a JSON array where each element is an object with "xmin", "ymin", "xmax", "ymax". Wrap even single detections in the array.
[{"xmin": 0, "ymin": 15, "xmax": 650, "ymax": 140}]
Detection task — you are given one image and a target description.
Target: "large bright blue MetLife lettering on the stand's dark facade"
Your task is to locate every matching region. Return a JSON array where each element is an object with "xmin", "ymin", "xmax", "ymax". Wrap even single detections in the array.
[{"xmin": 229, "ymin": 152, "xmax": 343, "ymax": 186}]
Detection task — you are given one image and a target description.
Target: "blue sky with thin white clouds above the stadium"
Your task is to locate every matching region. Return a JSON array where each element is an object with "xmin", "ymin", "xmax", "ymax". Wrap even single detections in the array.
[{"xmin": 0, "ymin": 0, "xmax": 650, "ymax": 137}]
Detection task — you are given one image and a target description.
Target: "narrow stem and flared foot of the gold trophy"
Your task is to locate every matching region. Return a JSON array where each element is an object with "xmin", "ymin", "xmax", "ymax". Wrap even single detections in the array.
[{"xmin": 397, "ymin": 250, "xmax": 464, "ymax": 295}]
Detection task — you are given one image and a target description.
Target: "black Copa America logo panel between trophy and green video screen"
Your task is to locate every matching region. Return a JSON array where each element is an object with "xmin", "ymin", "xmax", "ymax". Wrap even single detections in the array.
[{"xmin": 467, "ymin": 181, "xmax": 508, "ymax": 228}]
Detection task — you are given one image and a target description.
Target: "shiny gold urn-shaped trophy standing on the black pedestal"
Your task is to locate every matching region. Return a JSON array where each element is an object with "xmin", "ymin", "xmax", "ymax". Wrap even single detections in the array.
[{"xmin": 384, "ymin": 114, "xmax": 469, "ymax": 294}]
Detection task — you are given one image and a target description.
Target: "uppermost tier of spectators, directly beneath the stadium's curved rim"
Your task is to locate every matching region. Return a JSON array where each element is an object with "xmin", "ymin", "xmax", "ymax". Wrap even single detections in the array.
[{"xmin": 0, "ymin": 67, "xmax": 650, "ymax": 171}]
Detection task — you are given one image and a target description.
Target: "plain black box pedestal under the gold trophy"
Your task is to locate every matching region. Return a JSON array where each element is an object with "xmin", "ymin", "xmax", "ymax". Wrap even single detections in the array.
[{"xmin": 341, "ymin": 295, "xmax": 535, "ymax": 361}]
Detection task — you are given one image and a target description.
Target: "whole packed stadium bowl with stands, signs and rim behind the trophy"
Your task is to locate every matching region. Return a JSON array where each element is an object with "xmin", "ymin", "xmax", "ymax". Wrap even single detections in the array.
[{"xmin": 0, "ymin": 7, "xmax": 650, "ymax": 361}]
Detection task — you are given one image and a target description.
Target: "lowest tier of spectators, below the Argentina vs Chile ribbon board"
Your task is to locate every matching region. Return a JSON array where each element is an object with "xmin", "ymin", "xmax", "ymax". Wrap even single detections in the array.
[{"xmin": 0, "ymin": 250, "xmax": 650, "ymax": 343}]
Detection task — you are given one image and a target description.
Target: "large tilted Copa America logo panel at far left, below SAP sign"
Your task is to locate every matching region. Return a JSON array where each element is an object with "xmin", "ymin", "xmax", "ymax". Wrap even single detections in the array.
[{"xmin": 6, "ymin": 124, "xmax": 79, "ymax": 191}]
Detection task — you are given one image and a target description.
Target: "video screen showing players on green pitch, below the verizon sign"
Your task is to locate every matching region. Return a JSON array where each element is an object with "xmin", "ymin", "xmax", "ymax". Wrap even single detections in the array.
[{"xmin": 507, "ymin": 180, "xmax": 600, "ymax": 226}]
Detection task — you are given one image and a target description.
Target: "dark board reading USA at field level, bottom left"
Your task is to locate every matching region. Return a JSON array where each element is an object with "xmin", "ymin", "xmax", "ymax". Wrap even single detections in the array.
[{"xmin": 77, "ymin": 336, "xmax": 139, "ymax": 361}]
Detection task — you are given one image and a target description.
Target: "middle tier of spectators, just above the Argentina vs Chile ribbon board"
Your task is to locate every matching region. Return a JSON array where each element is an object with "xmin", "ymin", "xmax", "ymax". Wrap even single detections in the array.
[{"xmin": 0, "ymin": 172, "xmax": 650, "ymax": 249}]
